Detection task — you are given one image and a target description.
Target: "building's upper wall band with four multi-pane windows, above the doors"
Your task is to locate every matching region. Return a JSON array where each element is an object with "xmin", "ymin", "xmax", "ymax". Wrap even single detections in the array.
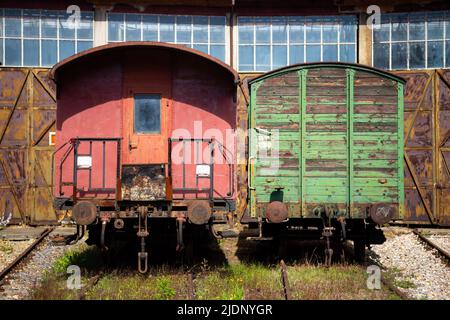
[{"xmin": 0, "ymin": 0, "xmax": 450, "ymax": 72}]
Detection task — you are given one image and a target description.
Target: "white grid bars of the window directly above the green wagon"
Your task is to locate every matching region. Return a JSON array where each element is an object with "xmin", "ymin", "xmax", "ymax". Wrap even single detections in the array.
[{"xmin": 235, "ymin": 15, "xmax": 358, "ymax": 73}]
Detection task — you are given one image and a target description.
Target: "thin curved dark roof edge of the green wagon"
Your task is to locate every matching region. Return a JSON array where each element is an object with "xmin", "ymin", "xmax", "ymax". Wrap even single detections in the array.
[{"xmin": 249, "ymin": 62, "xmax": 406, "ymax": 84}]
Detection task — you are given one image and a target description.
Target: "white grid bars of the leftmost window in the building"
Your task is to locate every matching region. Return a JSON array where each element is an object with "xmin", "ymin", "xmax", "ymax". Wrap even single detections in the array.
[{"xmin": 0, "ymin": 8, "xmax": 95, "ymax": 68}]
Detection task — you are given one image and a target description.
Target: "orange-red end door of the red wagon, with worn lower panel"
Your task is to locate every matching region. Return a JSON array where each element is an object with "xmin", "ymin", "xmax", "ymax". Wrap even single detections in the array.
[{"xmin": 122, "ymin": 63, "xmax": 171, "ymax": 200}]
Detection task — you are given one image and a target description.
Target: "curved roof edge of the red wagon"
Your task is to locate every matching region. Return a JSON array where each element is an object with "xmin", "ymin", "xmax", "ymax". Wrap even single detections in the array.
[{"xmin": 50, "ymin": 41, "xmax": 239, "ymax": 84}]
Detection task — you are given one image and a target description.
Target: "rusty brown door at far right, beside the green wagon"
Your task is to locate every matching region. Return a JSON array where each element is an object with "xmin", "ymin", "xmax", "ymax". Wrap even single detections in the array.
[{"xmin": 395, "ymin": 70, "xmax": 450, "ymax": 225}]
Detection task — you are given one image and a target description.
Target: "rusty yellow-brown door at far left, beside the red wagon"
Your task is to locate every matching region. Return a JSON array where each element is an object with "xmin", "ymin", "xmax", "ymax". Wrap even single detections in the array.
[{"xmin": 0, "ymin": 68, "xmax": 56, "ymax": 224}]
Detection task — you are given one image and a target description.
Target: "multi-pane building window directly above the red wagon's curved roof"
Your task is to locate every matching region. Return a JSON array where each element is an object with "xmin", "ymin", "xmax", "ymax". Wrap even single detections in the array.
[{"xmin": 108, "ymin": 13, "xmax": 226, "ymax": 61}]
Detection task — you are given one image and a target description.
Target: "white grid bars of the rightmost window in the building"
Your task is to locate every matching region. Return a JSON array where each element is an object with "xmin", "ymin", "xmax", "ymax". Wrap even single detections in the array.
[{"xmin": 372, "ymin": 11, "xmax": 450, "ymax": 70}]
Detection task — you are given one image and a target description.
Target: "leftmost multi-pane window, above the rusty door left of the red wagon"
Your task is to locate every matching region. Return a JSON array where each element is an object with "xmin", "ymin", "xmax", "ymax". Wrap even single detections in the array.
[{"xmin": 0, "ymin": 9, "xmax": 94, "ymax": 67}]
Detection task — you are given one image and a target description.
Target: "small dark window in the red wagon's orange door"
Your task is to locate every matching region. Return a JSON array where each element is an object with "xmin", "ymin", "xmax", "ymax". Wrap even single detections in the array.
[{"xmin": 134, "ymin": 94, "xmax": 161, "ymax": 133}]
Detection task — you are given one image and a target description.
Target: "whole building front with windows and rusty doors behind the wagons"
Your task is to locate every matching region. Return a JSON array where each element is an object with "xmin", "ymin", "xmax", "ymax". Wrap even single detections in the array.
[{"xmin": 0, "ymin": 0, "xmax": 450, "ymax": 223}]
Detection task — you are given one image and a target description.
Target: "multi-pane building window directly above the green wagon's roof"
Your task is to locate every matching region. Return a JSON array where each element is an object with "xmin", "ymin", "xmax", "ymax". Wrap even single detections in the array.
[{"xmin": 238, "ymin": 16, "xmax": 357, "ymax": 72}]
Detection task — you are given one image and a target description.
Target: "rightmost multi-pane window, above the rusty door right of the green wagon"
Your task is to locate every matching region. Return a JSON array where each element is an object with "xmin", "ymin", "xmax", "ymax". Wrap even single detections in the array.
[{"xmin": 372, "ymin": 11, "xmax": 450, "ymax": 70}]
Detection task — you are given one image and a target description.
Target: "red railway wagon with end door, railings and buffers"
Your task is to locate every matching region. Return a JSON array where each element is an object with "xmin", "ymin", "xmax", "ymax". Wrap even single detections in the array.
[{"xmin": 51, "ymin": 42, "xmax": 239, "ymax": 271}]
